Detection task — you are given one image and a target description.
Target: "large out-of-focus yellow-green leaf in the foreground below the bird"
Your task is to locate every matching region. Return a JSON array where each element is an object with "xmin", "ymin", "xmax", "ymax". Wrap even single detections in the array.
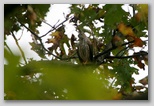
[{"xmin": 5, "ymin": 61, "xmax": 117, "ymax": 100}]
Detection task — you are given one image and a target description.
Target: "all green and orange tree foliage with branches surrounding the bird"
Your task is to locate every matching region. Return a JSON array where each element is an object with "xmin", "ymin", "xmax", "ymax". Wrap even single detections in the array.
[{"xmin": 4, "ymin": 4, "xmax": 148, "ymax": 100}]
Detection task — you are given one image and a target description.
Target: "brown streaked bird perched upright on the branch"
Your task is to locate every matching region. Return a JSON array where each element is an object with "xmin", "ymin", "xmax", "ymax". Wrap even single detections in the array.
[{"xmin": 77, "ymin": 30, "xmax": 93, "ymax": 64}]
